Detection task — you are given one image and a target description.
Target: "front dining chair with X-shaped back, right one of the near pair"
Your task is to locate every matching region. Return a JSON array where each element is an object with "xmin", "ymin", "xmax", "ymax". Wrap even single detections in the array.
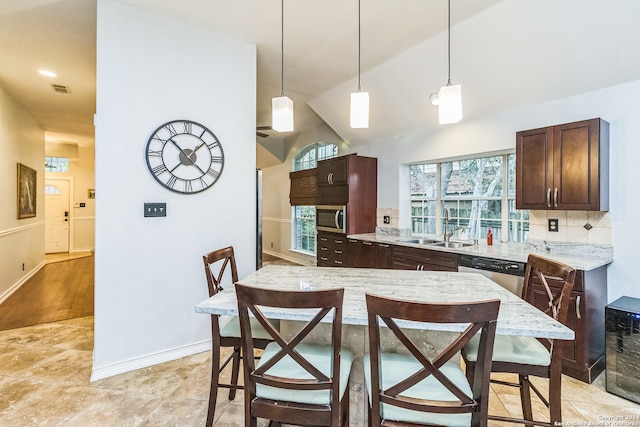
[{"xmin": 364, "ymin": 294, "xmax": 500, "ymax": 427}]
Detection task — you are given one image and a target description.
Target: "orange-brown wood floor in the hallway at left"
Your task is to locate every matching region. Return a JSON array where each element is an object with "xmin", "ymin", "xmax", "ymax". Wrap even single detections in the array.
[{"xmin": 0, "ymin": 256, "xmax": 93, "ymax": 330}]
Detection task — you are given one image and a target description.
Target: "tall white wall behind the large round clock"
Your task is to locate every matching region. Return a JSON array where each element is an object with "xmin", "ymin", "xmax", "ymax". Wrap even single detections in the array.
[{"xmin": 92, "ymin": 0, "xmax": 256, "ymax": 379}]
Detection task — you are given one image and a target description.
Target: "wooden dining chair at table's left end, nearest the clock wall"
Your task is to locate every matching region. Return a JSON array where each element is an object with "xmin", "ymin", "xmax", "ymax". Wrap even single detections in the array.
[{"xmin": 202, "ymin": 246, "xmax": 279, "ymax": 426}]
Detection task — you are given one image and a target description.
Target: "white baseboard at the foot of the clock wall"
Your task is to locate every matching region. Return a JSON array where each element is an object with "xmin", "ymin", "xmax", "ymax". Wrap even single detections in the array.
[{"xmin": 90, "ymin": 340, "xmax": 211, "ymax": 382}]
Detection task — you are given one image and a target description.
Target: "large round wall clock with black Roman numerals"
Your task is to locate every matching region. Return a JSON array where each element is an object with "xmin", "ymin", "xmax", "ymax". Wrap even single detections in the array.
[{"xmin": 146, "ymin": 120, "xmax": 224, "ymax": 194}]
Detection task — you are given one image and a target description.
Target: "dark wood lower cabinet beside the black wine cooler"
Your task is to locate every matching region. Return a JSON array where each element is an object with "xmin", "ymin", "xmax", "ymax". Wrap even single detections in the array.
[{"xmin": 534, "ymin": 266, "xmax": 607, "ymax": 383}]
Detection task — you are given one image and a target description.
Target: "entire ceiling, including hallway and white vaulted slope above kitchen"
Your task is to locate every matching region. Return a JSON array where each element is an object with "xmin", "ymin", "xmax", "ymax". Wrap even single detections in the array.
[{"xmin": 0, "ymin": 0, "xmax": 640, "ymax": 152}]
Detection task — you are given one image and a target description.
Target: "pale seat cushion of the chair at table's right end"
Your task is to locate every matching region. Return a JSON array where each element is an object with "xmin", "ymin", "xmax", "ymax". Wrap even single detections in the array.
[{"xmin": 462, "ymin": 335, "xmax": 551, "ymax": 366}]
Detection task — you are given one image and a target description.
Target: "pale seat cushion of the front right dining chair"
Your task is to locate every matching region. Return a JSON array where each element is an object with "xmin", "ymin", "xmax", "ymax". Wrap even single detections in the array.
[{"xmin": 363, "ymin": 353, "xmax": 472, "ymax": 426}]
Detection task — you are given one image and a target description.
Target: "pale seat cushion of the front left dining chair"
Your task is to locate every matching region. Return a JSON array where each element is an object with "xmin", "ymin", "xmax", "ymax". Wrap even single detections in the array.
[{"xmin": 256, "ymin": 342, "xmax": 353, "ymax": 405}]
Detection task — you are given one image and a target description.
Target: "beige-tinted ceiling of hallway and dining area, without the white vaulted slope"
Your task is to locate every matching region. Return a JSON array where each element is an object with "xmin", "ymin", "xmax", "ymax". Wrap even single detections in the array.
[{"xmin": 0, "ymin": 0, "xmax": 499, "ymax": 149}]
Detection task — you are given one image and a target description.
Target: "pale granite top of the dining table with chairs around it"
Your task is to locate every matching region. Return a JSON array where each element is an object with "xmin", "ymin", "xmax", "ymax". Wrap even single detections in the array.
[{"xmin": 195, "ymin": 265, "xmax": 574, "ymax": 339}]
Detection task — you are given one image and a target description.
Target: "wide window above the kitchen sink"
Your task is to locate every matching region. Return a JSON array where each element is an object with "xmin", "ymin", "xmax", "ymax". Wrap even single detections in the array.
[{"xmin": 410, "ymin": 154, "xmax": 529, "ymax": 242}]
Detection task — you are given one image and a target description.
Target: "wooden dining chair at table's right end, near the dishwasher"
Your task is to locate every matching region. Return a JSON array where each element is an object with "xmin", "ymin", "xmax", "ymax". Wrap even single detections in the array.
[{"xmin": 462, "ymin": 254, "xmax": 576, "ymax": 427}]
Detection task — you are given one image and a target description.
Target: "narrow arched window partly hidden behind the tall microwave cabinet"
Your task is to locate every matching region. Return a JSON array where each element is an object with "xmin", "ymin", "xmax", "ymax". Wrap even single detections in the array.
[{"xmin": 291, "ymin": 142, "xmax": 338, "ymax": 254}]
